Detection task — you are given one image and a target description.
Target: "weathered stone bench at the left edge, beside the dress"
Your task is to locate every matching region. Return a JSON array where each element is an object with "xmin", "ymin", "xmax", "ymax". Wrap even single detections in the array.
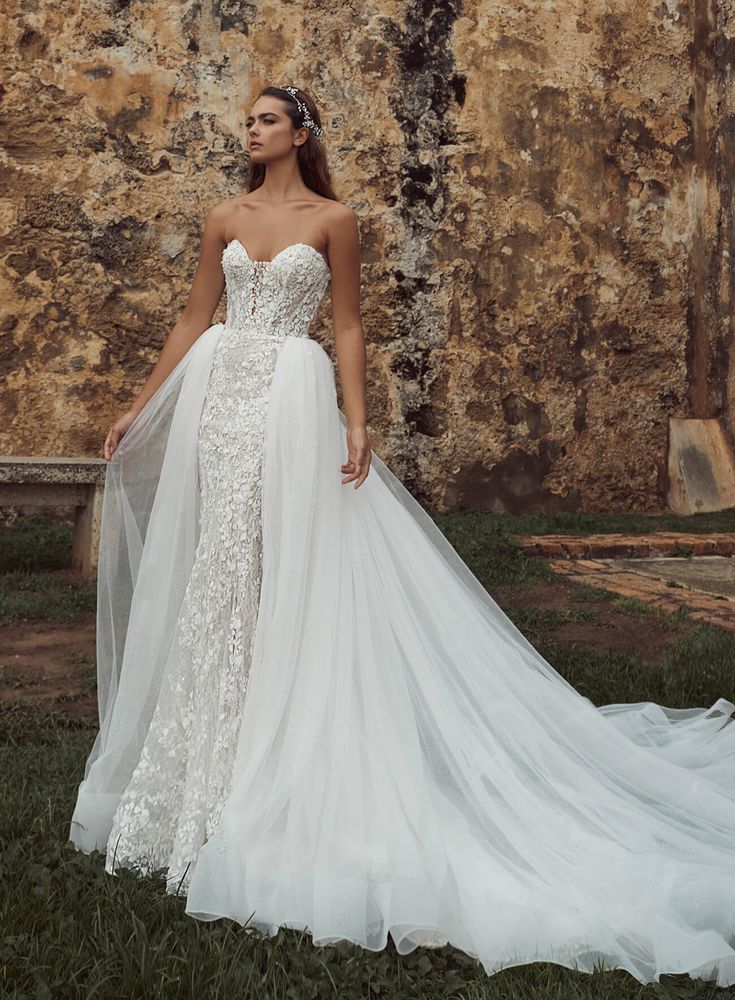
[{"xmin": 0, "ymin": 455, "xmax": 107, "ymax": 580}]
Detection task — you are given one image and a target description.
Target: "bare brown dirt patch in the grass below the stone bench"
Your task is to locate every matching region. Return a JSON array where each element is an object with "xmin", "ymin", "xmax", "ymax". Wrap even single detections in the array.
[{"xmin": 0, "ymin": 615, "xmax": 97, "ymax": 720}]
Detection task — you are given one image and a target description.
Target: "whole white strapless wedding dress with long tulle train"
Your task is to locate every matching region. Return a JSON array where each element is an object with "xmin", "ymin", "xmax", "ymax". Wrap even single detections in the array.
[{"xmin": 70, "ymin": 232, "xmax": 735, "ymax": 985}]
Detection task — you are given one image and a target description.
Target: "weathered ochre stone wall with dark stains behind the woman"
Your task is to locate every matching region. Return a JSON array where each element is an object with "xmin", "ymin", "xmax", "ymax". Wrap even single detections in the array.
[{"xmin": 0, "ymin": 0, "xmax": 735, "ymax": 511}]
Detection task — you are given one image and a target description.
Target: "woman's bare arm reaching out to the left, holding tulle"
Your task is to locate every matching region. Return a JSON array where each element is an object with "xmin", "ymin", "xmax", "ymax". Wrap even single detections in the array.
[{"xmin": 104, "ymin": 204, "xmax": 227, "ymax": 461}]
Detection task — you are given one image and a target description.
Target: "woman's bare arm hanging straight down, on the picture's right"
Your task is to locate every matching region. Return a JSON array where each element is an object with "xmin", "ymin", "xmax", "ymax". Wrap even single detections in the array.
[{"xmin": 327, "ymin": 204, "xmax": 371, "ymax": 489}]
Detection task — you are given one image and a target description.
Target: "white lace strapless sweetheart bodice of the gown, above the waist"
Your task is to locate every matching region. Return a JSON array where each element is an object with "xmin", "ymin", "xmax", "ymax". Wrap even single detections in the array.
[{"xmin": 222, "ymin": 240, "xmax": 330, "ymax": 340}]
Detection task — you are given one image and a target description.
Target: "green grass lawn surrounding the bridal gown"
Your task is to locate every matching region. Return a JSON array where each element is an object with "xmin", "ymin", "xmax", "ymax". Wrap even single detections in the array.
[{"xmin": 0, "ymin": 514, "xmax": 735, "ymax": 1000}]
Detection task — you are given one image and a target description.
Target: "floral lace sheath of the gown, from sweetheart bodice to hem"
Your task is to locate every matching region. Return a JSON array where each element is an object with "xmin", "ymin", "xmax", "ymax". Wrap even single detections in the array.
[{"xmin": 106, "ymin": 240, "xmax": 330, "ymax": 895}]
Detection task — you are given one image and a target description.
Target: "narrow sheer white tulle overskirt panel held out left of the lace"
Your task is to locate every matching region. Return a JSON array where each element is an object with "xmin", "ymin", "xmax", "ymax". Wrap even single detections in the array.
[{"xmin": 70, "ymin": 324, "xmax": 223, "ymax": 851}]
